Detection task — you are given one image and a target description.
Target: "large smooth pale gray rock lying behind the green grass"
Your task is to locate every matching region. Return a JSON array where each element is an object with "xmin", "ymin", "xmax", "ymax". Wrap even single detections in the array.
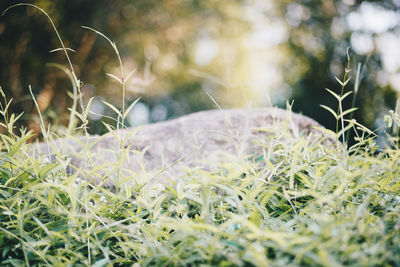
[{"xmin": 33, "ymin": 108, "xmax": 332, "ymax": 186}]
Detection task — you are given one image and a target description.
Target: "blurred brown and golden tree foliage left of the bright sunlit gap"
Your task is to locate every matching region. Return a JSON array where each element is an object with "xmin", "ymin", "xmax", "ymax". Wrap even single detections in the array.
[{"xmin": 0, "ymin": 0, "xmax": 248, "ymax": 135}]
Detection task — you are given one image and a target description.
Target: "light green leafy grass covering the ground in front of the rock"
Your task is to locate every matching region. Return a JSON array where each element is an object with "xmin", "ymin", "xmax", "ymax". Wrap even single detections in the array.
[{"xmin": 0, "ymin": 2, "xmax": 400, "ymax": 266}]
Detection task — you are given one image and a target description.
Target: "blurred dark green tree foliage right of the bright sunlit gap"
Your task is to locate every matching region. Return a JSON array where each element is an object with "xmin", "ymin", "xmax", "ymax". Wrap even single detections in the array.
[{"xmin": 276, "ymin": 0, "xmax": 400, "ymax": 137}]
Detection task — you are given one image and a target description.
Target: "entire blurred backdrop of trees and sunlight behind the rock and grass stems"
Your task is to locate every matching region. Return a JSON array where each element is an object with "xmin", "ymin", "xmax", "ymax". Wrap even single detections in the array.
[{"xmin": 0, "ymin": 0, "xmax": 400, "ymax": 140}]
